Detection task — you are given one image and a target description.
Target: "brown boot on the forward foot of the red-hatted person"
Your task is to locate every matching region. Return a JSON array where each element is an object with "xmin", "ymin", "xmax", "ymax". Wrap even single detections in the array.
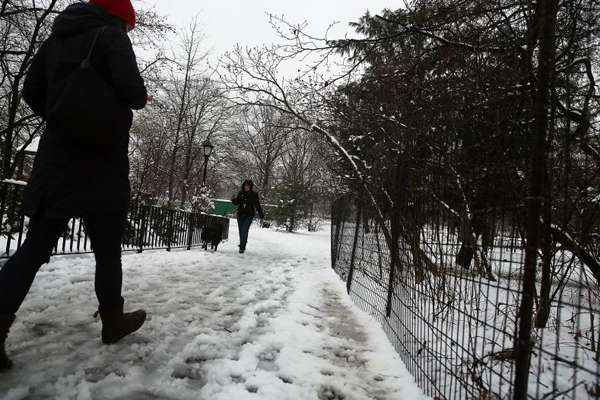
[{"xmin": 99, "ymin": 305, "xmax": 146, "ymax": 344}]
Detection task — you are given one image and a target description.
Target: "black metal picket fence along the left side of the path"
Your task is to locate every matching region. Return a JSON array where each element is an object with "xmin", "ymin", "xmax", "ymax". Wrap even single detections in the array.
[{"xmin": 0, "ymin": 182, "xmax": 229, "ymax": 259}]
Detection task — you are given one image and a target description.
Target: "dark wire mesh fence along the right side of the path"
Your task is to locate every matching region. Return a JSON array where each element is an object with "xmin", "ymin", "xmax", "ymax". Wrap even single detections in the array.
[{"xmin": 331, "ymin": 198, "xmax": 600, "ymax": 399}]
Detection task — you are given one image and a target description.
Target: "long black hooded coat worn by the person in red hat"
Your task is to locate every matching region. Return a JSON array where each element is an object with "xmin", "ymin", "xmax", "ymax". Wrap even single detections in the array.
[{"xmin": 23, "ymin": 3, "xmax": 147, "ymax": 217}]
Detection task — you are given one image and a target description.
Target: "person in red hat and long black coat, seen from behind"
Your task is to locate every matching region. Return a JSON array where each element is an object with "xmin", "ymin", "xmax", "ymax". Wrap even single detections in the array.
[{"xmin": 0, "ymin": 0, "xmax": 147, "ymax": 371}]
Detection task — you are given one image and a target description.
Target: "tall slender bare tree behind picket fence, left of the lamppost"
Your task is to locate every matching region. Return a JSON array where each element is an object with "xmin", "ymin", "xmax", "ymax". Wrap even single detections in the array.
[{"xmin": 132, "ymin": 19, "xmax": 230, "ymax": 205}]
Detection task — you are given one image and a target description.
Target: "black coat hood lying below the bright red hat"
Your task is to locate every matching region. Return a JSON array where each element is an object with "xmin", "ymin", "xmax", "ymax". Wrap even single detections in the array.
[{"xmin": 52, "ymin": 3, "xmax": 124, "ymax": 37}]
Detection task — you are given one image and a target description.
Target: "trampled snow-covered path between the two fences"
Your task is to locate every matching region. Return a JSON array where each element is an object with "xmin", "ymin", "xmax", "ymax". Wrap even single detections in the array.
[{"xmin": 0, "ymin": 224, "xmax": 422, "ymax": 400}]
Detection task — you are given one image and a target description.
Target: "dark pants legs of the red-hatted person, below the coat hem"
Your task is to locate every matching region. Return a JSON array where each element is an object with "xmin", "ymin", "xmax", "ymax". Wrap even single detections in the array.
[{"xmin": 0, "ymin": 214, "xmax": 125, "ymax": 315}]
